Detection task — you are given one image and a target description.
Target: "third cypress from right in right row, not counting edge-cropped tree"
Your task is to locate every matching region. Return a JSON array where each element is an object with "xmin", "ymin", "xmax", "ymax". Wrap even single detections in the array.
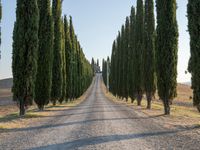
[{"xmin": 133, "ymin": 0, "xmax": 144, "ymax": 106}]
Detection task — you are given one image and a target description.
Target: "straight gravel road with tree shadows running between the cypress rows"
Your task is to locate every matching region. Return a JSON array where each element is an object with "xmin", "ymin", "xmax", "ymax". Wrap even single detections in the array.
[{"xmin": 0, "ymin": 75, "xmax": 200, "ymax": 150}]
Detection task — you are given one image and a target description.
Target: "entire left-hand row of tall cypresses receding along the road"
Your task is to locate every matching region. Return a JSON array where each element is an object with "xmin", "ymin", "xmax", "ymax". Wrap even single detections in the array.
[{"xmin": 12, "ymin": 0, "xmax": 93, "ymax": 115}]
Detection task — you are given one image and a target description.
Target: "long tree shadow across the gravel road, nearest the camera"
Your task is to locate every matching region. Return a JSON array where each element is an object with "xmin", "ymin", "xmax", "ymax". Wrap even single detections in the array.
[{"xmin": 29, "ymin": 127, "xmax": 200, "ymax": 150}]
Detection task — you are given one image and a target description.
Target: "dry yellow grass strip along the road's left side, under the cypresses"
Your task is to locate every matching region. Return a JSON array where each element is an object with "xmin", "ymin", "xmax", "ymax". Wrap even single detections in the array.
[{"xmin": 0, "ymin": 78, "xmax": 94, "ymax": 132}]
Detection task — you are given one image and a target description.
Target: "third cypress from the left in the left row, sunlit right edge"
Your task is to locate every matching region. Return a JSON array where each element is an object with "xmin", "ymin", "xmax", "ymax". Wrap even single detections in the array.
[{"xmin": 51, "ymin": 0, "xmax": 63, "ymax": 105}]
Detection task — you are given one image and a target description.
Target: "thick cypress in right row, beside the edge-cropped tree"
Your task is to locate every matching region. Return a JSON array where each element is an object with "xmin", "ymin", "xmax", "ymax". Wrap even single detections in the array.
[{"xmin": 156, "ymin": 0, "xmax": 178, "ymax": 114}]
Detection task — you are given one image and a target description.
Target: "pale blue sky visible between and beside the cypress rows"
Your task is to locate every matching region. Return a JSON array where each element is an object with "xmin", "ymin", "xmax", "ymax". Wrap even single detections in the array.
[{"xmin": 0, "ymin": 0, "xmax": 190, "ymax": 82}]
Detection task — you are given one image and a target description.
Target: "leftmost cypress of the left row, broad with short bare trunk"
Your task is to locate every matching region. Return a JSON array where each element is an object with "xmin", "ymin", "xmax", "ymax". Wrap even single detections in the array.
[{"xmin": 12, "ymin": 0, "xmax": 39, "ymax": 115}]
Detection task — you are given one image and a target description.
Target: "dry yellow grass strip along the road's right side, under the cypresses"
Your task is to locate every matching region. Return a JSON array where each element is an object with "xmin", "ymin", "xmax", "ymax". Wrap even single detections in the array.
[{"xmin": 101, "ymin": 82, "xmax": 200, "ymax": 127}]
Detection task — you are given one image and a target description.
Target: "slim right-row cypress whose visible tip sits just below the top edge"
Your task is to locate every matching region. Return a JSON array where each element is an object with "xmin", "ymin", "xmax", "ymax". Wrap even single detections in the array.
[{"xmin": 128, "ymin": 7, "xmax": 136, "ymax": 103}]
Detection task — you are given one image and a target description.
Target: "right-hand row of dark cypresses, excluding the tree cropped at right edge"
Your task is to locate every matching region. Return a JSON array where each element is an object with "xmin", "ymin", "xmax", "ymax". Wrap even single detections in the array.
[{"xmin": 106, "ymin": 0, "xmax": 178, "ymax": 114}]
